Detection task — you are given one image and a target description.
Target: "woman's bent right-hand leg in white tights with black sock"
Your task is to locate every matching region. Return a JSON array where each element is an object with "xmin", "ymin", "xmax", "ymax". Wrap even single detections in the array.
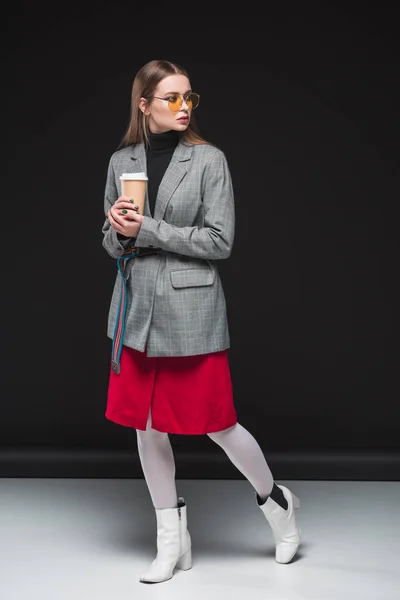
[{"xmin": 208, "ymin": 423, "xmax": 287, "ymax": 509}]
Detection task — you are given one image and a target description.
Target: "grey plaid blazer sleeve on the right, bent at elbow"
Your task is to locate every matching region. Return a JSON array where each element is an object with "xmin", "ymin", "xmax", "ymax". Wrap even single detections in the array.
[{"xmin": 136, "ymin": 149, "xmax": 235, "ymax": 260}]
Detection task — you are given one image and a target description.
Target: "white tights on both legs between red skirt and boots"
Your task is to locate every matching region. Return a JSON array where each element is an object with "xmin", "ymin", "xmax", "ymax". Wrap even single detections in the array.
[{"xmin": 136, "ymin": 413, "xmax": 274, "ymax": 509}]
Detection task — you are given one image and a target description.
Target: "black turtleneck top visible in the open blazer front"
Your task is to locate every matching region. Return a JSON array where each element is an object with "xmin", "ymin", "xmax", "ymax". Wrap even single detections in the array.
[{"xmin": 146, "ymin": 130, "xmax": 179, "ymax": 216}]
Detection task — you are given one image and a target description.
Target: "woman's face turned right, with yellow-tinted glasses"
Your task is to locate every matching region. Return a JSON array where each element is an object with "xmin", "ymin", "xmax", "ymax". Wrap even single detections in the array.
[{"xmin": 139, "ymin": 75, "xmax": 192, "ymax": 133}]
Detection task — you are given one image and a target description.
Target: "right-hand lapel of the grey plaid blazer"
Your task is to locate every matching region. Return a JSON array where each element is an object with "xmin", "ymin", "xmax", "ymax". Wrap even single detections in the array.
[{"xmin": 154, "ymin": 142, "xmax": 193, "ymax": 221}]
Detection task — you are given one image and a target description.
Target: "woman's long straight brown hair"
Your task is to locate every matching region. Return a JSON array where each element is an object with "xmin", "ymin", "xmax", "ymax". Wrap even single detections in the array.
[{"xmin": 119, "ymin": 60, "xmax": 209, "ymax": 148}]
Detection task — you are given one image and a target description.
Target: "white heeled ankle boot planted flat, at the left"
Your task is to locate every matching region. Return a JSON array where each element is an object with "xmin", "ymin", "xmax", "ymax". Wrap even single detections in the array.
[{"xmin": 140, "ymin": 498, "xmax": 192, "ymax": 583}]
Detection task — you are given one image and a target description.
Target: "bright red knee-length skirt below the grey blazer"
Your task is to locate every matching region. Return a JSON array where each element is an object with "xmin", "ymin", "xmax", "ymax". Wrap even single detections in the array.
[{"xmin": 105, "ymin": 346, "xmax": 237, "ymax": 435}]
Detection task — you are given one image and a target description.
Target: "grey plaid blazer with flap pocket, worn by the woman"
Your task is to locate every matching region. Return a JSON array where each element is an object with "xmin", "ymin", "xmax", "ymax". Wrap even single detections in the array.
[{"xmin": 102, "ymin": 141, "xmax": 235, "ymax": 356}]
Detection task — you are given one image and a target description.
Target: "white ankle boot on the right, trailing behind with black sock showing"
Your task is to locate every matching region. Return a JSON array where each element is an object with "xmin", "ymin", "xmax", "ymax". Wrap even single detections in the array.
[{"xmin": 256, "ymin": 485, "xmax": 301, "ymax": 564}]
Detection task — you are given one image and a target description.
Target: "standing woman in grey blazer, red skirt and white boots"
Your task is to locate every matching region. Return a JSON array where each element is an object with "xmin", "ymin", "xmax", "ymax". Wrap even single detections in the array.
[{"xmin": 103, "ymin": 60, "xmax": 300, "ymax": 583}]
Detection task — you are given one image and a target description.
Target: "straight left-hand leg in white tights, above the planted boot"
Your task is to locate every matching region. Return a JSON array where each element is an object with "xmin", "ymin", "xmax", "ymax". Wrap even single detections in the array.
[{"xmin": 136, "ymin": 411, "xmax": 178, "ymax": 509}]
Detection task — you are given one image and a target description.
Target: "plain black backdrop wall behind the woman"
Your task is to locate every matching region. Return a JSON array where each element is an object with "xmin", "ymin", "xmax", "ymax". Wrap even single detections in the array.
[{"xmin": 0, "ymin": 2, "xmax": 400, "ymax": 478}]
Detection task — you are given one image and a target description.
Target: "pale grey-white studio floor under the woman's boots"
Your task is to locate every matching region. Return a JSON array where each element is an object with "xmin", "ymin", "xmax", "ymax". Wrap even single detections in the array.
[{"xmin": 0, "ymin": 478, "xmax": 400, "ymax": 600}]
